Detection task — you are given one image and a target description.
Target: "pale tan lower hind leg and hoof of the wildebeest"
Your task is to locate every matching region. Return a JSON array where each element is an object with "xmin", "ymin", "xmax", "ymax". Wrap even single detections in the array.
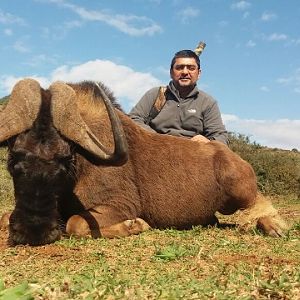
[{"xmin": 238, "ymin": 193, "xmax": 288, "ymax": 237}]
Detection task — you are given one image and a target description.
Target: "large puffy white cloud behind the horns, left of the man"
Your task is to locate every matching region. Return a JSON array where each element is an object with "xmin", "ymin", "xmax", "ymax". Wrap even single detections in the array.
[{"xmin": 0, "ymin": 60, "xmax": 162, "ymax": 110}]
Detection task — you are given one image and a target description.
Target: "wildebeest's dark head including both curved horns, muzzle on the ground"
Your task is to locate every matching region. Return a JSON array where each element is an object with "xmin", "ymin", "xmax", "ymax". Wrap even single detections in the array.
[{"xmin": 0, "ymin": 79, "xmax": 127, "ymax": 245}]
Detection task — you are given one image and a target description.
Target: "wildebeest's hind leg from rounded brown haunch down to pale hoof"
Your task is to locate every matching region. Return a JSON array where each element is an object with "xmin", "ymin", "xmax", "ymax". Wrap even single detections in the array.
[{"xmin": 218, "ymin": 158, "xmax": 287, "ymax": 237}]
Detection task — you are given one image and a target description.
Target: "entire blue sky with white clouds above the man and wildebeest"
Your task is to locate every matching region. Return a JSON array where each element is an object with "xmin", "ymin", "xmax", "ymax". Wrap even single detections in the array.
[{"xmin": 0, "ymin": 0, "xmax": 300, "ymax": 150}]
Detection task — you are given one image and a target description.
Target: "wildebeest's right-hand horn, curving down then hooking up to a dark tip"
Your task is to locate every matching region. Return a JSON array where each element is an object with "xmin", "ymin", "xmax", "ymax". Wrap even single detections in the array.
[{"xmin": 50, "ymin": 81, "xmax": 128, "ymax": 165}]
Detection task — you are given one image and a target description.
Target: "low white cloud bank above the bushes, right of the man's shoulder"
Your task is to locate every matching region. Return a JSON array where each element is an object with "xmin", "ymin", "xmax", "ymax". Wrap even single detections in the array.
[{"xmin": 222, "ymin": 114, "xmax": 300, "ymax": 150}]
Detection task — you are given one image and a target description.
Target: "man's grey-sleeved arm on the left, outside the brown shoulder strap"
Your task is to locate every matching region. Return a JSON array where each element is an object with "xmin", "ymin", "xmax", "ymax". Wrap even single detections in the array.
[{"xmin": 129, "ymin": 87, "xmax": 159, "ymax": 132}]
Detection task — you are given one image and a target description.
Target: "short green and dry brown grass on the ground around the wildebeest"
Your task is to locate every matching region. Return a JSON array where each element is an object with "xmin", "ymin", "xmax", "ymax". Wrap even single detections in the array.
[{"xmin": 0, "ymin": 150, "xmax": 300, "ymax": 300}]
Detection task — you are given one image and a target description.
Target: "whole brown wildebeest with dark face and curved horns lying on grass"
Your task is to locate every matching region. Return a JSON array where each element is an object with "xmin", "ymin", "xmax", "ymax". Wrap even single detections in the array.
[{"xmin": 0, "ymin": 79, "xmax": 284, "ymax": 245}]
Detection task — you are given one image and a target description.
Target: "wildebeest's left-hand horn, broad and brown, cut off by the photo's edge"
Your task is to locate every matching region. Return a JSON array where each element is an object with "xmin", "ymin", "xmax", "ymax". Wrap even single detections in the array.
[{"xmin": 0, "ymin": 78, "xmax": 41, "ymax": 142}]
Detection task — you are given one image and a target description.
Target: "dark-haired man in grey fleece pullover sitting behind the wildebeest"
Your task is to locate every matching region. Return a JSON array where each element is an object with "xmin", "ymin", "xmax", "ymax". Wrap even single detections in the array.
[{"xmin": 129, "ymin": 50, "xmax": 228, "ymax": 144}]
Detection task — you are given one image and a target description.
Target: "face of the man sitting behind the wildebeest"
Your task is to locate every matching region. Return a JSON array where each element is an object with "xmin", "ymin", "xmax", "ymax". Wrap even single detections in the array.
[{"xmin": 170, "ymin": 57, "xmax": 201, "ymax": 88}]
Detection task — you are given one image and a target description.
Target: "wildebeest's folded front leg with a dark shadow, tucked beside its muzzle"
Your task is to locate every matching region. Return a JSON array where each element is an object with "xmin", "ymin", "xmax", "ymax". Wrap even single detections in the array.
[{"xmin": 66, "ymin": 207, "xmax": 150, "ymax": 238}]
